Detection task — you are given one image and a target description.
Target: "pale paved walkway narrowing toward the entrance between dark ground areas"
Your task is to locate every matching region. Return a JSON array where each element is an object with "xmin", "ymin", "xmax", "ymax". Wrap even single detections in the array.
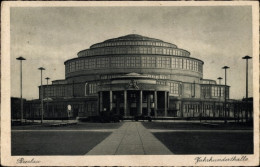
[{"xmin": 87, "ymin": 122, "xmax": 172, "ymax": 155}]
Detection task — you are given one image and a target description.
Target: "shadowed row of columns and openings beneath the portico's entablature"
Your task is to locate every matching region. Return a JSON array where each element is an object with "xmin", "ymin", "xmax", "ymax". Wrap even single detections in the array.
[{"xmin": 99, "ymin": 90, "xmax": 168, "ymax": 118}]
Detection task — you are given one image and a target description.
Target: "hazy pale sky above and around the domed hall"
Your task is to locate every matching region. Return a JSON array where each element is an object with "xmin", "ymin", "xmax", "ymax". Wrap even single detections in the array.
[{"xmin": 10, "ymin": 6, "xmax": 253, "ymax": 100}]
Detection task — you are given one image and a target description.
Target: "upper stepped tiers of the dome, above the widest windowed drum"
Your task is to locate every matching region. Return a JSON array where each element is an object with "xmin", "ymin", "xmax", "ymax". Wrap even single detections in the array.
[{"xmin": 78, "ymin": 34, "xmax": 190, "ymax": 57}]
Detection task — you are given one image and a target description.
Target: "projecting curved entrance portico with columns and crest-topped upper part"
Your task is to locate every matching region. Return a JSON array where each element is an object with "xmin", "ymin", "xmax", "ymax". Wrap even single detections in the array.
[{"xmin": 98, "ymin": 74, "xmax": 169, "ymax": 118}]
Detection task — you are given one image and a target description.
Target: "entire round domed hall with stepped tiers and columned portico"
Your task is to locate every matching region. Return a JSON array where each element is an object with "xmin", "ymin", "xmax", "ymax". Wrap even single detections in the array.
[{"xmin": 25, "ymin": 34, "xmax": 232, "ymax": 119}]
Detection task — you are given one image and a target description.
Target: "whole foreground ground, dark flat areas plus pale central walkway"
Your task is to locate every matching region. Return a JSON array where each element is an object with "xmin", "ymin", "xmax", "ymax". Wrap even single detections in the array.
[{"xmin": 12, "ymin": 121, "xmax": 253, "ymax": 156}]
